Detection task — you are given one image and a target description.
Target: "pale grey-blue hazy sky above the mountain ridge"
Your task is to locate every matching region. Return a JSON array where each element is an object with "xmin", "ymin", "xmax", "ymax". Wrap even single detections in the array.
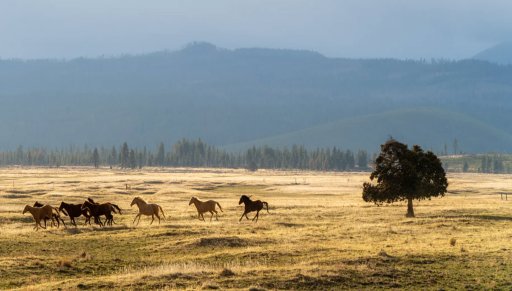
[{"xmin": 0, "ymin": 0, "xmax": 512, "ymax": 59}]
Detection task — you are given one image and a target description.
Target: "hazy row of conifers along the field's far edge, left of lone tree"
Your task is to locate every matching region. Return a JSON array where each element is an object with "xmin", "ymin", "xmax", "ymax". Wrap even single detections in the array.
[{"xmin": 0, "ymin": 139, "xmax": 370, "ymax": 171}]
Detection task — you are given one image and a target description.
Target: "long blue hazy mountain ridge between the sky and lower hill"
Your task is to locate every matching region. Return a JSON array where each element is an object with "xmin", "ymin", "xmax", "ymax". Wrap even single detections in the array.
[{"xmin": 0, "ymin": 43, "xmax": 512, "ymax": 151}]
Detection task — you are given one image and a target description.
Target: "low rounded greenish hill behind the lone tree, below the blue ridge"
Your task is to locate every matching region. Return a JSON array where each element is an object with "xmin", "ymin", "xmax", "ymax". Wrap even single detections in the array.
[{"xmin": 224, "ymin": 107, "xmax": 512, "ymax": 153}]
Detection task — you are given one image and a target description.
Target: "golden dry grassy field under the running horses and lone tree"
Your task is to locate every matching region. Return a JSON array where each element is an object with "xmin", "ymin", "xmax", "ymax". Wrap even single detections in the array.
[{"xmin": 0, "ymin": 168, "xmax": 512, "ymax": 290}]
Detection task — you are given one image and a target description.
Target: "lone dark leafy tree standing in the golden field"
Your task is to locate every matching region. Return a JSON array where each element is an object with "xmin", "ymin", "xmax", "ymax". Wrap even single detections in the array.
[{"xmin": 363, "ymin": 138, "xmax": 448, "ymax": 217}]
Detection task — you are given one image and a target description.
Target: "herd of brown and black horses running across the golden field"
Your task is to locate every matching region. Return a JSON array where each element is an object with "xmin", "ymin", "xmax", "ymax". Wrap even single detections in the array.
[{"xmin": 23, "ymin": 195, "xmax": 270, "ymax": 230}]
